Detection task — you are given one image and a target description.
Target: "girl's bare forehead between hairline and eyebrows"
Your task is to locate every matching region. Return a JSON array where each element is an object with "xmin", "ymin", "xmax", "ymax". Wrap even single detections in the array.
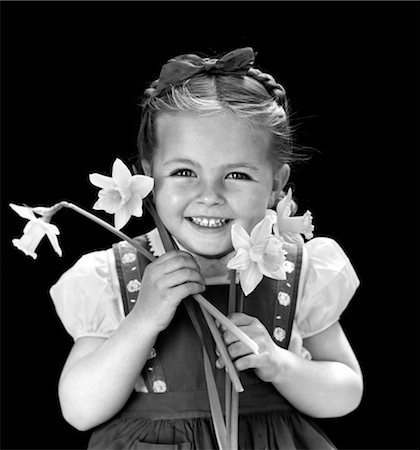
[{"xmin": 155, "ymin": 112, "xmax": 270, "ymax": 164}]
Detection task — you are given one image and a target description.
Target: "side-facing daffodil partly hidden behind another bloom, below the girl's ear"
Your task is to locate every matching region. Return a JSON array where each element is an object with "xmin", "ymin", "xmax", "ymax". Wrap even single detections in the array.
[{"xmin": 276, "ymin": 189, "xmax": 314, "ymax": 239}]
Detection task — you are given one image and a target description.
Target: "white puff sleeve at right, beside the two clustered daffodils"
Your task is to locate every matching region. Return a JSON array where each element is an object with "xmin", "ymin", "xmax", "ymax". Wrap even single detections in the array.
[{"xmin": 296, "ymin": 238, "xmax": 360, "ymax": 339}]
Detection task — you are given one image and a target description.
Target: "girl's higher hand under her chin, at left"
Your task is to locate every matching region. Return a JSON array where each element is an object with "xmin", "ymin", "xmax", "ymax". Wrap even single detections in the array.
[{"xmin": 133, "ymin": 250, "xmax": 205, "ymax": 332}]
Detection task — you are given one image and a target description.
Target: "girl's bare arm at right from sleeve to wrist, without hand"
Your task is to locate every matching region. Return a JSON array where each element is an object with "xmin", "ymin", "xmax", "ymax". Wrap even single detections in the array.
[{"xmin": 272, "ymin": 322, "xmax": 363, "ymax": 417}]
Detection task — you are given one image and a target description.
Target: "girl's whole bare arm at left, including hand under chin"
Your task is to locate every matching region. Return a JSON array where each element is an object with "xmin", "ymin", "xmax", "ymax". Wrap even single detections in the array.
[{"xmin": 59, "ymin": 251, "xmax": 204, "ymax": 430}]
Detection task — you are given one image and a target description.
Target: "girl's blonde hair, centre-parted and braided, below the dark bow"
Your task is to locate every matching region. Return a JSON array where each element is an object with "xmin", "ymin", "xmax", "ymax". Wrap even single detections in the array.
[{"xmin": 137, "ymin": 68, "xmax": 296, "ymax": 166}]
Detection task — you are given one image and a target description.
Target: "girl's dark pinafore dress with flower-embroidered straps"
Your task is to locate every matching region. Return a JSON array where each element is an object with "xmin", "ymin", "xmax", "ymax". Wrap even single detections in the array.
[{"xmin": 88, "ymin": 237, "xmax": 335, "ymax": 450}]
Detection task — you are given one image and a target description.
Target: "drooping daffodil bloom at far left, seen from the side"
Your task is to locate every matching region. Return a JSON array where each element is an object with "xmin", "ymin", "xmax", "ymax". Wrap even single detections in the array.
[{"xmin": 9, "ymin": 203, "xmax": 62, "ymax": 259}]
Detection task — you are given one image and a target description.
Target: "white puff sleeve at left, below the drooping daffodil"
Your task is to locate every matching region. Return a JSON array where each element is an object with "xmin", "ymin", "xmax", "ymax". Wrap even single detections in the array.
[{"xmin": 50, "ymin": 249, "xmax": 124, "ymax": 340}]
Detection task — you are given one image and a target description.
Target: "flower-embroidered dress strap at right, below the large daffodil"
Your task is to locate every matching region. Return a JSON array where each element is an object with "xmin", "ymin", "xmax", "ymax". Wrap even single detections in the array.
[{"xmin": 273, "ymin": 243, "xmax": 302, "ymax": 348}]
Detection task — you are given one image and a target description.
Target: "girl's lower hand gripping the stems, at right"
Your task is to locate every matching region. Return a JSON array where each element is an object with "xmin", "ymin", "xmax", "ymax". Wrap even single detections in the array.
[{"xmin": 216, "ymin": 313, "xmax": 283, "ymax": 382}]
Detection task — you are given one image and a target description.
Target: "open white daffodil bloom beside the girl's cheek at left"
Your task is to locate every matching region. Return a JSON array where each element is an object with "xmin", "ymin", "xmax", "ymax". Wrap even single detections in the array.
[{"xmin": 89, "ymin": 158, "xmax": 154, "ymax": 230}]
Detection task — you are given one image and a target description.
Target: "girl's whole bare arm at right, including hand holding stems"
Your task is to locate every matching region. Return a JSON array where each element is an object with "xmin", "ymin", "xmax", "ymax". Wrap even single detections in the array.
[{"xmin": 217, "ymin": 314, "xmax": 363, "ymax": 417}]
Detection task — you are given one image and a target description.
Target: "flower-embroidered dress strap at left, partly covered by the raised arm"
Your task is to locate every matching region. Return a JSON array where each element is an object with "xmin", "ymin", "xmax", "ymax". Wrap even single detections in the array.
[{"xmin": 112, "ymin": 236, "xmax": 167, "ymax": 393}]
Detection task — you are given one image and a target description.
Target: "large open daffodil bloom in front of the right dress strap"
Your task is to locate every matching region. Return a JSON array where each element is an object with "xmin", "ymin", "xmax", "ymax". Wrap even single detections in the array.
[{"xmin": 227, "ymin": 214, "xmax": 286, "ymax": 295}]
